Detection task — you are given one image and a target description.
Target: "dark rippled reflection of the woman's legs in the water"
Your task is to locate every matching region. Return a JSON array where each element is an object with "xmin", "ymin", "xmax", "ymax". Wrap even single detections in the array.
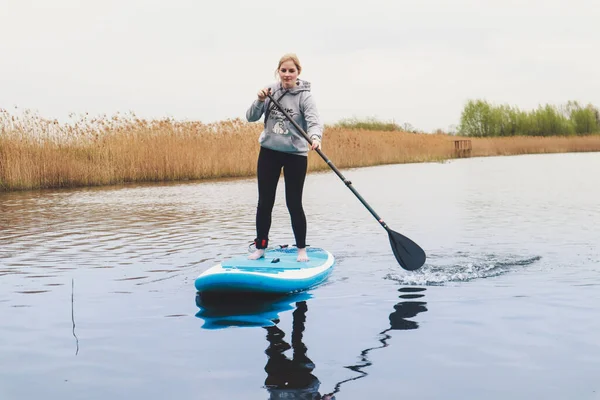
[{"xmin": 265, "ymin": 301, "xmax": 334, "ymax": 400}]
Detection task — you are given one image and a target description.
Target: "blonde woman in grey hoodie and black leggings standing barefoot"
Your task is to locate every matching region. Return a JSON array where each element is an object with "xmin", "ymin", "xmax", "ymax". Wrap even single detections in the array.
[{"xmin": 246, "ymin": 54, "xmax": 323, "ymax": 261}]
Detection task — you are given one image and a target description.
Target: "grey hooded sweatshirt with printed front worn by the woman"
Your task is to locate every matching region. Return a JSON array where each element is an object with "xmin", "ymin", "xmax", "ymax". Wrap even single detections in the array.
[{"xmin": 246, "ymin": 79, "xmax": 323, "ymax": 156}]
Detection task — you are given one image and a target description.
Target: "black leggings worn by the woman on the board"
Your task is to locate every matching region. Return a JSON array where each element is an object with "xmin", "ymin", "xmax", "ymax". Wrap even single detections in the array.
[{"xmin": 256, "ymin": 147, "xmax": 308, "ymax": 249}]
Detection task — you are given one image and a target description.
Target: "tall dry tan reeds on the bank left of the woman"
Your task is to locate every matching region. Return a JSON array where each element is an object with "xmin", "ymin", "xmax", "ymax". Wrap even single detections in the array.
[{"xmin": 0, "ymin": 111, "xmax": 259, "ymax": 190}]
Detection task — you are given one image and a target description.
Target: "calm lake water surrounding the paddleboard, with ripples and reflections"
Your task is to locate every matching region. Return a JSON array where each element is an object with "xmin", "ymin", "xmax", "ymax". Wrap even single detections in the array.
[{"xmin": 0, "ymin": 153, "xmax": 600, "ymax": 400}]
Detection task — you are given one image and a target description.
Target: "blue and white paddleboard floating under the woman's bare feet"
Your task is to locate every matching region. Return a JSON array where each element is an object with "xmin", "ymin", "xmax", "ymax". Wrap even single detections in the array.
[{"xmin": 195, "ymin": 247, "xmax": 335, "ymax": 294}]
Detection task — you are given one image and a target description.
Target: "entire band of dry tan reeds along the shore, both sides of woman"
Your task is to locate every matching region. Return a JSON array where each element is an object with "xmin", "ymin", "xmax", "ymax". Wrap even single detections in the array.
[{"xmin": 0, "ymin": 113, "xmax": 600, "ymax": 192}]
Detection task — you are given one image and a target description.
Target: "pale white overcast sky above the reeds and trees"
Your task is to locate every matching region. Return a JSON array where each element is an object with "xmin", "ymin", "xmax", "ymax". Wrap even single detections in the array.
[{"xmin": 0, "ymin": 0, "xmax": 600, "ymax": 131}]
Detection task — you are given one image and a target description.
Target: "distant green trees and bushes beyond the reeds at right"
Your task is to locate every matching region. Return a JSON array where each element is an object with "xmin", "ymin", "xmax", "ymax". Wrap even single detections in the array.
[{"xmin": 458, "ymin": 100, "xmax": 600, "ymax": 137}]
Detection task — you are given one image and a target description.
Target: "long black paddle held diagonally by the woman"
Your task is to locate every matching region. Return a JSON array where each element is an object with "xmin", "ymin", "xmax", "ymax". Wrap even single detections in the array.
[{"xmin": 267, "ymin": 92, "xmax": 426, "ymax": 271}]
